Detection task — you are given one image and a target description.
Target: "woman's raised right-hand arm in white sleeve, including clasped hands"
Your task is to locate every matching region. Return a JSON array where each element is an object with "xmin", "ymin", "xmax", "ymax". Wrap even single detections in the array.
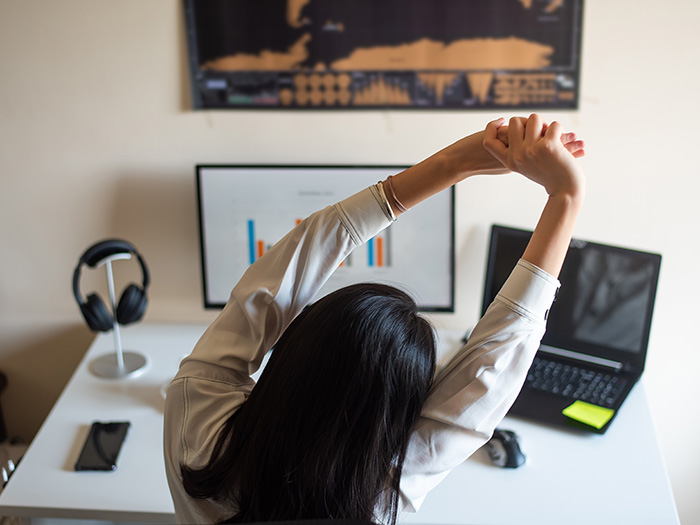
[{"xmin": 401, "ymin": 115, "xmax": 584, "ymax": 510}]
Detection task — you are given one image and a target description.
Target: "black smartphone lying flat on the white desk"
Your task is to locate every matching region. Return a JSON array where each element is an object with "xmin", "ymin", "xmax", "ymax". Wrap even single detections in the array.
[{"xmin": 75, "ymin": 421, "xmax": 131, "ymax": 470}]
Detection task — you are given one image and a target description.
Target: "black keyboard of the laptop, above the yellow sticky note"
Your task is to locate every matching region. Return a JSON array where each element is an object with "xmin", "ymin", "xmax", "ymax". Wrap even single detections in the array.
[{"xmin": 525, "ymin": 357, "xmax": 627, "ymax": 408}]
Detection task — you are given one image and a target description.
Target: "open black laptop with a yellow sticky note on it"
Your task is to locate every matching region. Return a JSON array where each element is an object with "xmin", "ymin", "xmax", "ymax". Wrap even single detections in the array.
[{"xmin": 482, "ymin": 225, "xmax": 661, "ymax": 434}]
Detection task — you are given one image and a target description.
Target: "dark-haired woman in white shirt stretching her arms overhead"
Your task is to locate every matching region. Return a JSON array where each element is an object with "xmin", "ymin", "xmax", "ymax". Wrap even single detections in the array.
[{"xmin": 165, "ymin": 115, "xmax": 584, "ymax": 524}]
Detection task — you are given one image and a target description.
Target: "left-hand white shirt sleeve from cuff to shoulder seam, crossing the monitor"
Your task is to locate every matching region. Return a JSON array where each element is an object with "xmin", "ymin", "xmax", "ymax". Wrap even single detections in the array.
[{"xmin": 179, "ymin": 182, "xmax": 394, "ymax": 380}]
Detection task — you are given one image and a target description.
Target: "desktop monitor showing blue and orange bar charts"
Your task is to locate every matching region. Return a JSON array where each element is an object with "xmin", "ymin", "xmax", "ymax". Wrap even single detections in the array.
[{"xmin": 196, "ymin": 165, "xmax": 454, "ymax": 312}]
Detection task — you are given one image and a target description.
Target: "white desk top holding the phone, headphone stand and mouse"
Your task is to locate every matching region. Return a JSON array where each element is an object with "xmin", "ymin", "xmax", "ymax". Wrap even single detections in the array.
[{"xmin": 0, "ymin": 324, "xmax": 679, "ymax": 525}]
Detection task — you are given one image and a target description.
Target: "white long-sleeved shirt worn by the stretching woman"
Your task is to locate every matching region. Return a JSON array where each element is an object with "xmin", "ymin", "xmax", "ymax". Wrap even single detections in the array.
[{"xmin": 164, "ymin": 186, "xmax": 559, "ymax": 523}]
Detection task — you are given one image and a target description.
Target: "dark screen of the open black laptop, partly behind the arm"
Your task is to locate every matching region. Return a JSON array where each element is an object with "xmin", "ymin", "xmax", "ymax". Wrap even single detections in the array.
[{"xmin": 482, "ymin": 226, "xmax": 661, "ymax": 371}]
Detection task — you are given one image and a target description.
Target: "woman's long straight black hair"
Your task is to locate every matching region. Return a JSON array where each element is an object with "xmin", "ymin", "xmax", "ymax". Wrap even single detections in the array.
[{"xmin": 182, "ymin": 284, "xmax": 435, "ymax": 524}]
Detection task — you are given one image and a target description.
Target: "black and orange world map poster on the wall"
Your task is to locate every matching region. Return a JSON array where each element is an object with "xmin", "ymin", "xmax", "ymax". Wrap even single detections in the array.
[{"xmin": 185, "ymin": 0, "xmax": 583, "ymax": 110}]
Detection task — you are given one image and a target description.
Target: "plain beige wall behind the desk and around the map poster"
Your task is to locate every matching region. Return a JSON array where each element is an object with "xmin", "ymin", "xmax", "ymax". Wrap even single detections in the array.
[{"xmin": 0, "ymin": 0, "xmax": 700, "ymax": 523}]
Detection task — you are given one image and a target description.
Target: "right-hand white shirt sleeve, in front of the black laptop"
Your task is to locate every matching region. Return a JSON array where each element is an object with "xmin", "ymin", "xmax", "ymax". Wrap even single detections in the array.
[{"xmin": 401, "ymin": 260, "xmax": 559, "ymax": 511}]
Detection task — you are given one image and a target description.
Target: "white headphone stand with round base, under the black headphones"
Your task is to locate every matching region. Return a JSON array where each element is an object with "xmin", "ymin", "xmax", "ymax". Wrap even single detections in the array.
[{"xmin": 90, "ymin": 253, "xmax": 147, "ymax": 379}]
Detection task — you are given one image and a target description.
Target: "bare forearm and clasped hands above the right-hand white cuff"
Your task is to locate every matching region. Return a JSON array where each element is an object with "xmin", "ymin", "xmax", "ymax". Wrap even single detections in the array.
[{"xmin": 483, "ymin": 115, "xmax": 585, "ymax": 277}]
